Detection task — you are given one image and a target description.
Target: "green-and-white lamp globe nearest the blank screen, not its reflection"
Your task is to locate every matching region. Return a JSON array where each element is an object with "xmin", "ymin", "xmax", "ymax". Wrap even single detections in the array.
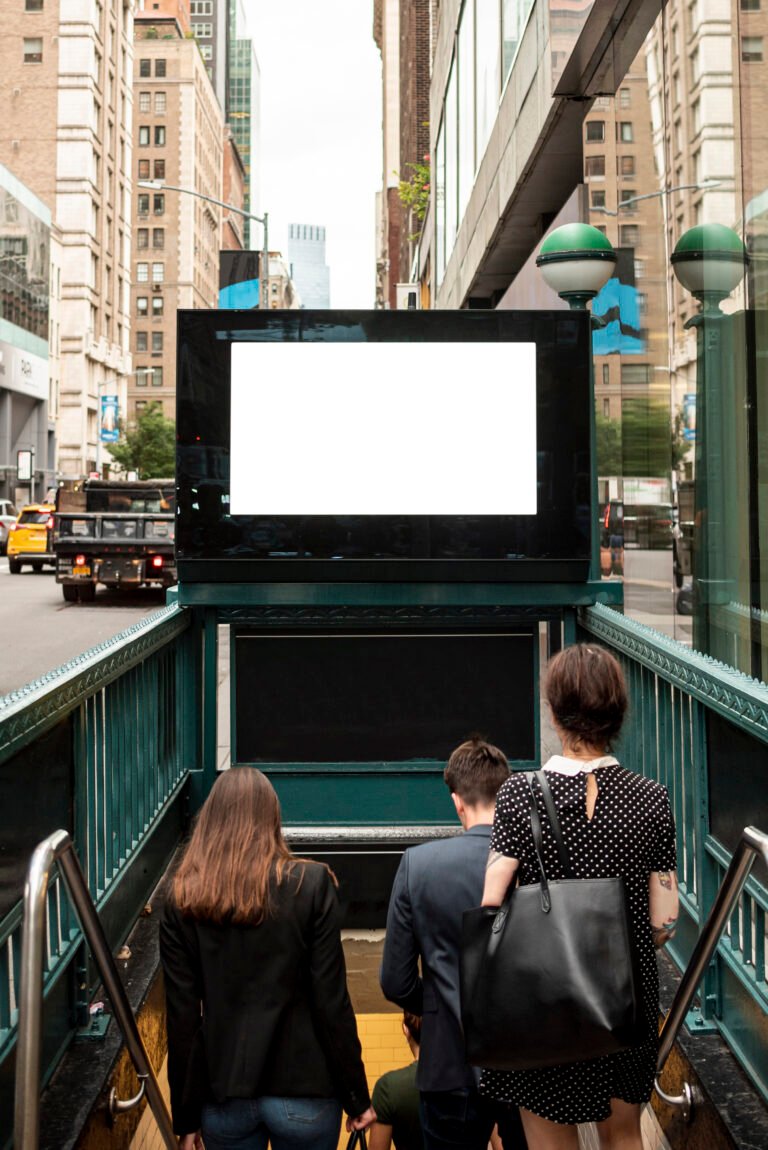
[{"xmin": 536, "ymin": 223, "xmax": 616, "ymax": 307}]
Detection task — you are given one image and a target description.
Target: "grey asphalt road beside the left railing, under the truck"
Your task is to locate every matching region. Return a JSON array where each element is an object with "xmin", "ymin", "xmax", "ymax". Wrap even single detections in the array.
[{"xmin": 0, "ymin": 555, "xmax": 166, "ymax": 696}]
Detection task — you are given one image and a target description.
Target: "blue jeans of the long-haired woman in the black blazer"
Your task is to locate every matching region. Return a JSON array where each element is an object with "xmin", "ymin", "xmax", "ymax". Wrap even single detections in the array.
[{"xmin": 202, "ymin": 1098, "xmax": 341, "ymax": 1150}]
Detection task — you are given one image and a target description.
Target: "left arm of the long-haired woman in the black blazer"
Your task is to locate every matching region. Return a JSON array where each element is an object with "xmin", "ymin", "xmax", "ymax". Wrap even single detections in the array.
[{"xmin": 160, "ymin": 904, "xmax": 202, "ymax": 1136}]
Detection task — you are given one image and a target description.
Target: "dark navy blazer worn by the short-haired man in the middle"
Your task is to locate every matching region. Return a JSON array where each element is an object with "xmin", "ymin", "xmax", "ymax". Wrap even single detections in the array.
[{"xmin": 381, "ymin": 825, "xmax": 491, "ymax": 1090}]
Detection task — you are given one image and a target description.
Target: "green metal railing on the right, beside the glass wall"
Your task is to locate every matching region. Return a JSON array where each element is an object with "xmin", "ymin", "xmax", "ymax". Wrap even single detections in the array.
[{"xmin": 578, "ymin": 606, "xmax": 768, "ymax": 1101}]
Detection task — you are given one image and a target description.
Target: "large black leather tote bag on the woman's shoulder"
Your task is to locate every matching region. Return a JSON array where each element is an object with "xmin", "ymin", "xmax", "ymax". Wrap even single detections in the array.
[{"xmin": 461, "ymin": 771, "xmax": 648, "ymax": 1071}]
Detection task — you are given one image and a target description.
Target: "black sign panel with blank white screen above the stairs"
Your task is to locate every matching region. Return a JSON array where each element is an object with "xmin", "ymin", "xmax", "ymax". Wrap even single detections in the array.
[{"xmin": 177, "ymin": 311, "xmax": 591, "ymax": 583}]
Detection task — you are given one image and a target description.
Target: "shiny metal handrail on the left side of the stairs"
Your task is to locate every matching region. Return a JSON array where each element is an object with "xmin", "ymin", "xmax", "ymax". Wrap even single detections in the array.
[{"xmin": 14, "ymin": 830, "xmax": 178, "ymax": 1150}]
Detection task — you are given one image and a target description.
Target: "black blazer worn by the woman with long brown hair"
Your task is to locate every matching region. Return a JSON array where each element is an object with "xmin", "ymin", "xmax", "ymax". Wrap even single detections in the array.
[{"xmin": 160, "ymin": 863, "xmax": 370, "ymax": 1134}]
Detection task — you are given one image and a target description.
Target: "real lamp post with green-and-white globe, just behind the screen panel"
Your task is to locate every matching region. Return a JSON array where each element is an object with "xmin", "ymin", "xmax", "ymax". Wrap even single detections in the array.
[{"xmin": 536, "ymin": 223, "xmax": 616, "ymax": 580}]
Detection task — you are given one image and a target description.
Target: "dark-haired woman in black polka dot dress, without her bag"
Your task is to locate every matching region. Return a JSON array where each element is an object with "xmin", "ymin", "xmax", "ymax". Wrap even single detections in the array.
[{"xmin": 481, "ymin": 644, "xmax": 677, "ymax": 1150}]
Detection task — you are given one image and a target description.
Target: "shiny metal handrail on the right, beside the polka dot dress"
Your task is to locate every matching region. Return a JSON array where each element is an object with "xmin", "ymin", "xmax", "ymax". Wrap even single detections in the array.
[{"xmin": 654, "ymin": 827, "xmax": 768, "ymax": 1121}]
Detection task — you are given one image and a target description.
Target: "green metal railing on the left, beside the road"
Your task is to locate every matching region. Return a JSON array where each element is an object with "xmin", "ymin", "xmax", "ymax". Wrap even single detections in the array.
[{"xmin": 0, "ymin": 606, "xmax": 202, "ymax": 1145}]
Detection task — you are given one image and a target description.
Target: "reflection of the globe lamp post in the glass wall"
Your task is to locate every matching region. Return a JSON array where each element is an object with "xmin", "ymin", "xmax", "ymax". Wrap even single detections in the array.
[{"xmin": 671, "ymin": 223, "xmax": 748, "ymax": 665}]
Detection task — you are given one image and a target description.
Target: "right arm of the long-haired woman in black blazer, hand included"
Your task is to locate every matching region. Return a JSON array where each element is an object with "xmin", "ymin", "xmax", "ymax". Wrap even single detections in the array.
[{"xmin": 305, "ymin": 863, "xmax": 376, "ymax": 1129}]
